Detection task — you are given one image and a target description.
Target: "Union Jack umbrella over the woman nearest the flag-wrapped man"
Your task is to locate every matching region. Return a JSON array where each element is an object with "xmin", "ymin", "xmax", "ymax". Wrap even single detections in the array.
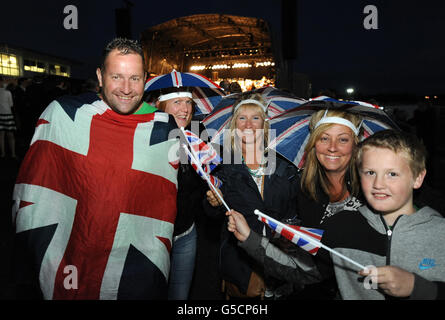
[{"xmin": 144, "ymin": 70, "xmax": 225, "ymax": 115}]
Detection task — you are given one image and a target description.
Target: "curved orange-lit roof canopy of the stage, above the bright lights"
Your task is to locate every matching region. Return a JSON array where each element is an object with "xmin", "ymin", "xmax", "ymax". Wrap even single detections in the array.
[{"xmin": 141, "ymin": 14, "xmax": 273, "ymax": 73}]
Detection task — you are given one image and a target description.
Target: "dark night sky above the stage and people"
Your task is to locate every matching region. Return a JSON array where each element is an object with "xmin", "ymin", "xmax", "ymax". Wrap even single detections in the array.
[{"xmin": 0, "ymin": 0, "xmax": 445, "ymax": 95}]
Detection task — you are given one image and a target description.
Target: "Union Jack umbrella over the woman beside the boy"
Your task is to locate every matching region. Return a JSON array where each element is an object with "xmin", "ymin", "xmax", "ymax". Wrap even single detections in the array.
[{"xmin": 268, "ymin": 96, "xmax": 399, "ymax": 168}]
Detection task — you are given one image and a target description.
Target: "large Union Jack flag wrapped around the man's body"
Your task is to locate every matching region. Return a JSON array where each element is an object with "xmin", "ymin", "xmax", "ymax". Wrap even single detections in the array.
[{"xmin": 13, "ymin": 94, "xmax": 179, "ymax": 300}]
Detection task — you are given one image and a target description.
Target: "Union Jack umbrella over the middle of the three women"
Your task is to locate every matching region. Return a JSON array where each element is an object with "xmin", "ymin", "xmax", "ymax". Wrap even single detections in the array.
[{"xmin": 202, "ymin": 86, "xmax": 307, "ymax": 144}]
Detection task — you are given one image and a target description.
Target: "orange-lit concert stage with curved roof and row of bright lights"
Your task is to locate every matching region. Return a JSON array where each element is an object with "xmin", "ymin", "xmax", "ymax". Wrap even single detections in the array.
[{"xmin": 141, "ymin": 14, "xmax": 275, "ymax": 90}]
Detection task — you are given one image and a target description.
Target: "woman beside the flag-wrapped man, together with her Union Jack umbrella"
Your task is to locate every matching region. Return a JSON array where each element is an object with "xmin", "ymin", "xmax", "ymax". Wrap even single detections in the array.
[{"xmin": 144, "ymin": 70, "xmax": 223, "ymax": 300}]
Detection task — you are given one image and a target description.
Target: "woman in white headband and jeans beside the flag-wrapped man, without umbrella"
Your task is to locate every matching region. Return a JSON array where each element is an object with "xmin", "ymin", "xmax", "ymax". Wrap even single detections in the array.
[{"xmin": 149, "ymin": 87, "xmax": 207, "ymax": 300}]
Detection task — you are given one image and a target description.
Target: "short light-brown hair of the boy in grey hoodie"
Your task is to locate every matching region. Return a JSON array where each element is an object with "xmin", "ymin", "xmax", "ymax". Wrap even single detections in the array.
[{"xmin": 357, "ymin": 129, "xmax": 427, "ymax": 178}]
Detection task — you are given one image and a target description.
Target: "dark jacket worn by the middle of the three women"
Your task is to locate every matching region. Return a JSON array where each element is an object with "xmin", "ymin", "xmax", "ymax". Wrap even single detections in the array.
[{"xmin": 204, "ymin": 154, "xmax": 297, "ymax": 293}]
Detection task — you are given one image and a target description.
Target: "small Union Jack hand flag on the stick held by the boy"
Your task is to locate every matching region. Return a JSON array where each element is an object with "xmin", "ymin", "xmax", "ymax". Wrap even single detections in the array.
[{"xmin": 257, "ymin": 213, "xmax": 324, "ymax": 255}]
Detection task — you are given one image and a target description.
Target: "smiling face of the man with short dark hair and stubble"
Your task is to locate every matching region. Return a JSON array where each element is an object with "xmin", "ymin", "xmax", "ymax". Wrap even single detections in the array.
[{"xmin": 96, "ymin": 50, "xmax": 145, "ymax": 114}]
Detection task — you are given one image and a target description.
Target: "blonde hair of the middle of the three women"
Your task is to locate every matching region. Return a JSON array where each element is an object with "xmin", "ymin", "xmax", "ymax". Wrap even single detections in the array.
[{"xmin": 224, "ymin": 93, "xmax": 270, "ymax": 151}]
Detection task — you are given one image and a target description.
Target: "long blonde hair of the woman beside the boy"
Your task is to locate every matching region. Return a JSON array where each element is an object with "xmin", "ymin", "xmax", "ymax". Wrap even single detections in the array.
[{"xmin": 301, "ymin": 110, "xmax": 362, "ymax": 201}]
